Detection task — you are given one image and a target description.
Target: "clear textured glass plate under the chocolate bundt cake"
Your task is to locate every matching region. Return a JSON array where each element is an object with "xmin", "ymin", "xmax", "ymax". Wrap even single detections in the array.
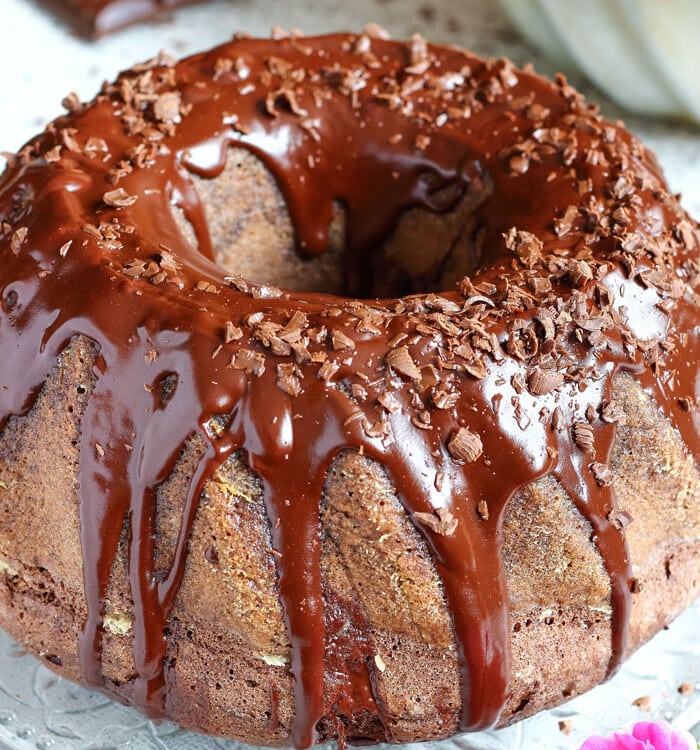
[{"xmin": 0, "ymin": 600, "xmax": 700, "ymax": 750}]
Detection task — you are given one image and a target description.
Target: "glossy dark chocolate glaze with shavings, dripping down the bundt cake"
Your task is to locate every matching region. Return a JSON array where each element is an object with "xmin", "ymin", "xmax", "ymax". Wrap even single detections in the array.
[{"xmin": 0, "ymin": 34, "xmax": 700, "ymax": 747}]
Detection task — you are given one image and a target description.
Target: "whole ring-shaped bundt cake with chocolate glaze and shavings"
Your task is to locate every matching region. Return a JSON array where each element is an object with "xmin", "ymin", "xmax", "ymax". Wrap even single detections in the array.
[{"xmin": 0, "ymin": 28, "xmax": 700, "ymax": 747}]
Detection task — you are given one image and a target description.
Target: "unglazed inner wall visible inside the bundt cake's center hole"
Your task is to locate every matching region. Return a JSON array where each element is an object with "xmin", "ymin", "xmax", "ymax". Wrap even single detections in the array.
[{"xmin": 175, "ymin": 149, "xmax": 480, "ymax": 297}]
